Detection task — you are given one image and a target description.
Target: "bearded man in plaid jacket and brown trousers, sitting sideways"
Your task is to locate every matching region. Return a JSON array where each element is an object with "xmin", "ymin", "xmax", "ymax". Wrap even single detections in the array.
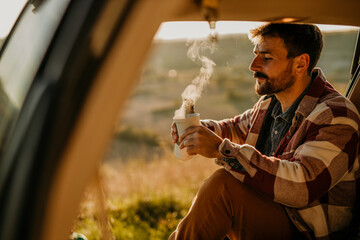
[{"xmin": 170, "ymin": 23, "xmax": 360, "ymax": 240}]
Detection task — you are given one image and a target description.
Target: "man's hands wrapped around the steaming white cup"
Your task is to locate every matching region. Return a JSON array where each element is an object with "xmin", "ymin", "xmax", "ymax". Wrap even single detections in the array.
[{"xmin": 173, "ymin": 124, "xmax": 223, "ymax": 158}]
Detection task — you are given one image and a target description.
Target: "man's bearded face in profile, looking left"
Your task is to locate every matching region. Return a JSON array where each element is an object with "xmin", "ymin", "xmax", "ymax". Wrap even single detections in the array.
[{"xmin": 250, "ymin": 37, "xmax": 295, "ymax": 95}]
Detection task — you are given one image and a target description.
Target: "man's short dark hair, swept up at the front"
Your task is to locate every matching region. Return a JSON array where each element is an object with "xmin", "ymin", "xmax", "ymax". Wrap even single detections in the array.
[{"xmin": 250, "ymin": 23, "xmax": 323, "ymax": 75}]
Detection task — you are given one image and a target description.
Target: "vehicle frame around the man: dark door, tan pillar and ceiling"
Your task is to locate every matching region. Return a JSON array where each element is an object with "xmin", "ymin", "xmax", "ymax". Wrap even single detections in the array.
[{"xmin": 0, "ymin": 0, "xmax": 360, "ymax": 240}]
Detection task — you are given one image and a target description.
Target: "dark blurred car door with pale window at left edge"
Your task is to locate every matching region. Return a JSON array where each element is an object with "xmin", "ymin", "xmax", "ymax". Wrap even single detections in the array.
[{"xmin": 0, "ymin": 0, "xmax": 135, "ymax": 239}]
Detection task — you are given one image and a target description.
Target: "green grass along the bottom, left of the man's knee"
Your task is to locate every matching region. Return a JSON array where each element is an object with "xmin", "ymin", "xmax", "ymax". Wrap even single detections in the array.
[{"xmin": 74, "ymin": 196, "xmax": 189, "ymax": 240}]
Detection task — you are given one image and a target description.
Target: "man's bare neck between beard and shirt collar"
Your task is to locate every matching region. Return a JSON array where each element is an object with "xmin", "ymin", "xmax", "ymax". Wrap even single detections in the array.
[{"xmin": 275, "ymin": 75, "xmax": 311, "ymax": 113}]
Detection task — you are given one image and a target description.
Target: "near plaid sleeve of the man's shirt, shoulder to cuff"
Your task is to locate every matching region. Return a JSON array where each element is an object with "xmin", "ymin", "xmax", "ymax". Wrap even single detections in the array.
[{"xmin": 219, "ymin": 97, "xmax": 359, "ymax": 208}]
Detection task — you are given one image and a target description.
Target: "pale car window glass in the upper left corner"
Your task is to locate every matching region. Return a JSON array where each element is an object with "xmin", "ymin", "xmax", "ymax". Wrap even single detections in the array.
[{"xmin": 0, "ymin": 0, "xmax": 69, "ymax": 154}]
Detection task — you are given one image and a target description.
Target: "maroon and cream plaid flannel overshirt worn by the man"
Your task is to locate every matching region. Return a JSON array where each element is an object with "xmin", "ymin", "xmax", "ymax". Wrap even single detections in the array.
[{"xmin": 202, "ymin": 69, "xmax": 360, "ymax": 239}]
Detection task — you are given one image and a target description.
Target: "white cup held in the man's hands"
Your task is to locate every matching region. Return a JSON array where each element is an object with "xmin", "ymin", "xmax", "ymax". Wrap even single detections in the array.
[{"xmin": 173, "ymin": 113, "xmax": 200, "ymax": 160}]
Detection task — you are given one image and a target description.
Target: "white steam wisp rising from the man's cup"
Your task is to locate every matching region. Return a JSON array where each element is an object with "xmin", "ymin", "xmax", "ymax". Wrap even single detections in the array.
[{"xmin": 174, "ymin": 40, "xmax": 215, "ymax": 119}]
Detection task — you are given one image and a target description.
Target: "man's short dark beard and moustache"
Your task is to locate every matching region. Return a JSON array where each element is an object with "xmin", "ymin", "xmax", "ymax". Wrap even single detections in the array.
[{"xmin": 254, "ymin": 62, "xmax": 295, "ymax": 95}]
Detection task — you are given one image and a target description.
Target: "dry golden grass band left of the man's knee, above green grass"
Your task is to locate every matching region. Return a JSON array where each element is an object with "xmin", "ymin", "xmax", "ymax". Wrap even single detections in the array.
[{"xmin": 102, "ymin": 153, "xmax": 218, "ymax": 201}]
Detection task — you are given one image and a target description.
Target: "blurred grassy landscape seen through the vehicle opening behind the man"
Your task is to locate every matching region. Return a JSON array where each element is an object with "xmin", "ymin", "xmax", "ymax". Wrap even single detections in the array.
[{"xmin": 72, "ymin": 31, "xmax": 357, "ymax": 240}]
